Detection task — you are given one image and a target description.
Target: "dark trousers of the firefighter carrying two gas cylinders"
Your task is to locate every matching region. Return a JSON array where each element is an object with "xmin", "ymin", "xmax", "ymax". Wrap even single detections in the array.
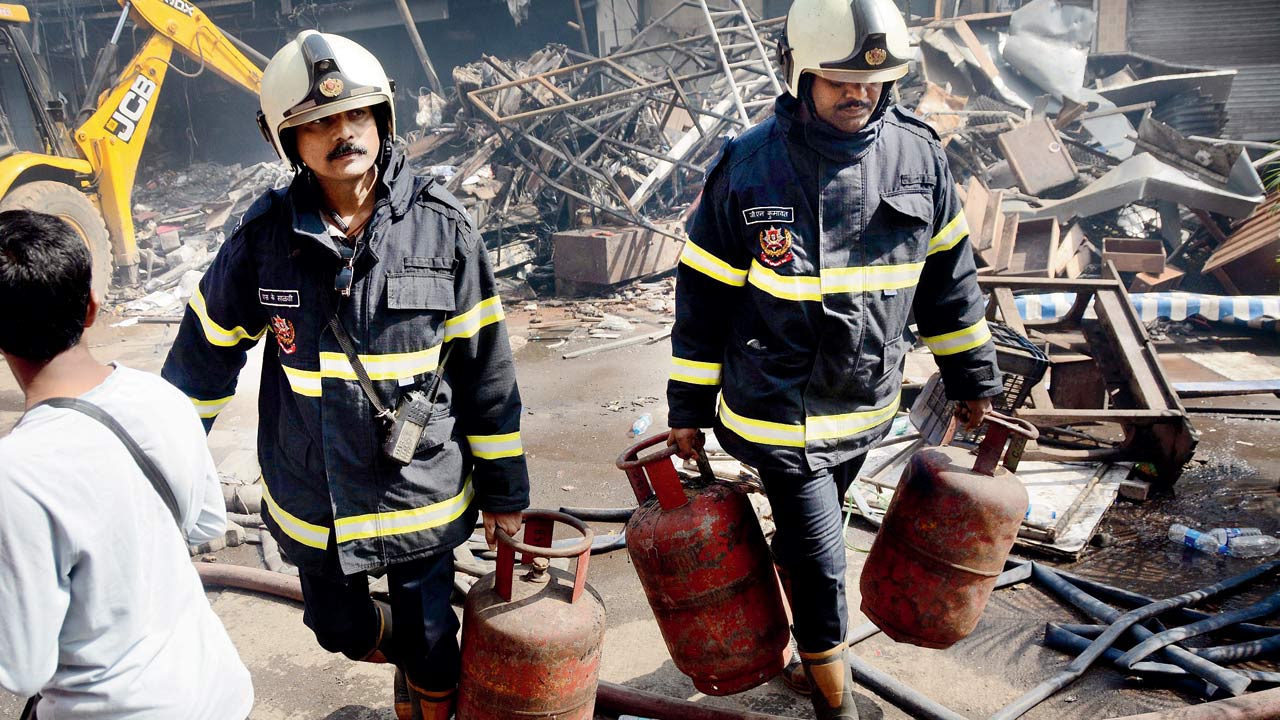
[{"xmin": 760, "ymin": 455, "xmax": 867, "ymax": 652}]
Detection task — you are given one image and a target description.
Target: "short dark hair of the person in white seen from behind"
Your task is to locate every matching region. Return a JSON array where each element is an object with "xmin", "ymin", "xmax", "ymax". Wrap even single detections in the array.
[{"xmin": 0, "ymin": 210, "xmax": 93, "ymax": 363}]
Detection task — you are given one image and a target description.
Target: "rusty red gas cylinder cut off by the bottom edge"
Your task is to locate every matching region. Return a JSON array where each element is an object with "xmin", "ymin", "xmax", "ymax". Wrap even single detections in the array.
[{"xmin": 457, "ymin": 510, "xmax": 604, "ymax": 720}]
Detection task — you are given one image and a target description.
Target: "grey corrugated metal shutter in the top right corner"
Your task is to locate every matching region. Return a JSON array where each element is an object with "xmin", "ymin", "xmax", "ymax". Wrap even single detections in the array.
[{"xmin": 1129, "ymin": 0, "xmax": 1280, "ymax": 140}]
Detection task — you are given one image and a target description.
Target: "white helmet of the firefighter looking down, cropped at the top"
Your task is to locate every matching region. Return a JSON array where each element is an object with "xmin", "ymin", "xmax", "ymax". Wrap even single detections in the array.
[{"xmin": 778, "ymin": 0, "xmax": 911, "ymax": 96}]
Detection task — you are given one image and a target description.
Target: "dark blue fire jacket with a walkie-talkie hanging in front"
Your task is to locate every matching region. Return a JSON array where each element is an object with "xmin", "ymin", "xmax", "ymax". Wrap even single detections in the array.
[{"xmin": 163, "ymin": 149, "xmax": 529, "ymax": 574}]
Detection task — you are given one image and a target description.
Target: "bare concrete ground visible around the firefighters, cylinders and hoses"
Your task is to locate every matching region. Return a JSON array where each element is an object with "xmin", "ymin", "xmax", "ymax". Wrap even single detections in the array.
[{"xmin": 0, "ymin": 304, "xmax": 1280, "ymax": 720}]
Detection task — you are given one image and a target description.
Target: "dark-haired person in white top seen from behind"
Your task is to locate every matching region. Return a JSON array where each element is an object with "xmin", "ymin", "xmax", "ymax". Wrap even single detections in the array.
[{"xmin": 0, "ymin": 210, "xmax": 253, "ymax": 720}]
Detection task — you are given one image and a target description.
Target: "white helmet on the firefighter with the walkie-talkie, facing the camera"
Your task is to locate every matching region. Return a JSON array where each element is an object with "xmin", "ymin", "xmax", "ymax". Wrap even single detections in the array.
[{"xmin": 257, "ymin": 29, "xmax": 396, "ymax": 164}]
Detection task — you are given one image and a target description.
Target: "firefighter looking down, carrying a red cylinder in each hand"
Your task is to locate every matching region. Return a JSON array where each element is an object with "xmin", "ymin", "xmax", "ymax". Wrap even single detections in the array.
[{"xmin": 667, "ymin": 0, "xmax": 1002, "ymax": 720}]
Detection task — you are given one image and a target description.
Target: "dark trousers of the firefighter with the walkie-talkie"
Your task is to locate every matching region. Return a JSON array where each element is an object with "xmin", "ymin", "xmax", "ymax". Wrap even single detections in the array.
[{"xmin": 301, "ymin": 551, "xmax": 461, "ymax": 691}]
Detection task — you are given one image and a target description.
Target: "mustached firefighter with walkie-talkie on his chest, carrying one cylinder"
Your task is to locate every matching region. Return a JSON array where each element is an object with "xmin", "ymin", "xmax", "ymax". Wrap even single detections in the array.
[{"xmin": 164, "ymin": 31, "xmax": 529, "ymax": 720}]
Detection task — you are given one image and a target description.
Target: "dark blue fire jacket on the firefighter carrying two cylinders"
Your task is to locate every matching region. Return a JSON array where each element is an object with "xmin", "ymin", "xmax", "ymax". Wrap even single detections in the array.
[{"xmin": 667, "ymin": 95, "xmax": 1001, "ymax": 471}]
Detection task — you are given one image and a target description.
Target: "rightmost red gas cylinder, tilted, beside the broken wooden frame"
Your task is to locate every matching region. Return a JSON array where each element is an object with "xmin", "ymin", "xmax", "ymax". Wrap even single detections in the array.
[{"xmin": 860, "ymin": 415, "xmax": 1038, "ymax": 648}]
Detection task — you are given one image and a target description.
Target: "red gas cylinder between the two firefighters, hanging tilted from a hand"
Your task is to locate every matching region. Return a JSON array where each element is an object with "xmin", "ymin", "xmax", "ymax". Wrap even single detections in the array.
[{"xmin": 617, "ymin": 434, "xmax": 790, "ymax": 696}]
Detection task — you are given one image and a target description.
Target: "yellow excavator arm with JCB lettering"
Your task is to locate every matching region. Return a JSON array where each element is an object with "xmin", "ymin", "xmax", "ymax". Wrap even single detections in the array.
[{"xmin": 74, "ymin": 0, "xmax": 262, "ymax": 272}]
